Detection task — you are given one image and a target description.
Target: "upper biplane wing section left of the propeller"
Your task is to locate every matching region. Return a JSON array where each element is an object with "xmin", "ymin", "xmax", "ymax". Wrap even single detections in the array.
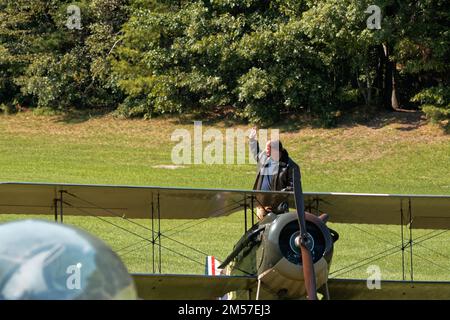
[{"xmin": 0, "ymin": 183, "xmax": 289, "ymax": 219}]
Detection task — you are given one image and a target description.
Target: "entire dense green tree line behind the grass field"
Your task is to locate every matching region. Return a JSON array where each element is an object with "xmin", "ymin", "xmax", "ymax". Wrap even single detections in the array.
[{"xmin": 0, "ymin": 0, "xmax": 450, "ymax": 125}]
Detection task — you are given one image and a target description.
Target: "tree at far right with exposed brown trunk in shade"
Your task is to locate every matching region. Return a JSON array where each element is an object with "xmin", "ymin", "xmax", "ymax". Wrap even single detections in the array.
[{"xmin": 303, "ymin": 0, "xmax": 449, "ymax": 110}]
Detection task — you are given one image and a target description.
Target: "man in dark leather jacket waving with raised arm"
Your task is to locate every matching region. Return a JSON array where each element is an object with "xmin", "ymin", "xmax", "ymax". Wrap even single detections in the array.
[{"xmin": 249, "ymin": 128, "xmax": 294, "ymax": 220}]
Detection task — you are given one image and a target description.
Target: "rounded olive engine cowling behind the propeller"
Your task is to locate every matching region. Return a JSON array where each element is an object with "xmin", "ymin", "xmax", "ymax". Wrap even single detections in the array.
[{"xmin": 257, "ymin": 212, "xmax": 336, "ymax": 298}]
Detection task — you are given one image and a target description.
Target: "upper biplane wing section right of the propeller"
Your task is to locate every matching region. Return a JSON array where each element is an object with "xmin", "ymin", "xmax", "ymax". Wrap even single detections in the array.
[{"xmin": 305, "ymin": 193, "xmax": 450, "ymax": 229}]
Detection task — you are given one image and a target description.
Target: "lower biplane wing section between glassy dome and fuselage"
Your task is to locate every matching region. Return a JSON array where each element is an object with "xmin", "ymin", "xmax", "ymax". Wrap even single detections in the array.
[{"xmin": 132, "ymin": 274, "xmax": 257, "ymax": 300}]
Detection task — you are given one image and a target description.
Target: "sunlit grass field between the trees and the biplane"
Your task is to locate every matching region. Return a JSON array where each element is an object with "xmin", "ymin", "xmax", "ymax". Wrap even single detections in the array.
[{"xmin": 0, "ymin": 112, "xmax": 450, "ymax": 280}]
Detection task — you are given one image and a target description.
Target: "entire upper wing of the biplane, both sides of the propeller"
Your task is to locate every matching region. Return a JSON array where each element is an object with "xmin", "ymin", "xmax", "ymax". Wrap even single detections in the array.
[{"xmin": 0, "ymin": 183, "xmax": 450, "ymax": 229}]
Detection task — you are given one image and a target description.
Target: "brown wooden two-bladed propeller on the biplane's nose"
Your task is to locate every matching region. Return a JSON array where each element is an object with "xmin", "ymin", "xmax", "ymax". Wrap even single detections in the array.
[{"xmin": 292, "ymin": 161, "xmax": 317, "ymax": 300}]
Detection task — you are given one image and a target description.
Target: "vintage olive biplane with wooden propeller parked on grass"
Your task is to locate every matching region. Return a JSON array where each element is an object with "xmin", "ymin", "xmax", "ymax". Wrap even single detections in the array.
[{"xmin": 0, "ymin": 164, "xmax": 450, "ymax": 299}]
